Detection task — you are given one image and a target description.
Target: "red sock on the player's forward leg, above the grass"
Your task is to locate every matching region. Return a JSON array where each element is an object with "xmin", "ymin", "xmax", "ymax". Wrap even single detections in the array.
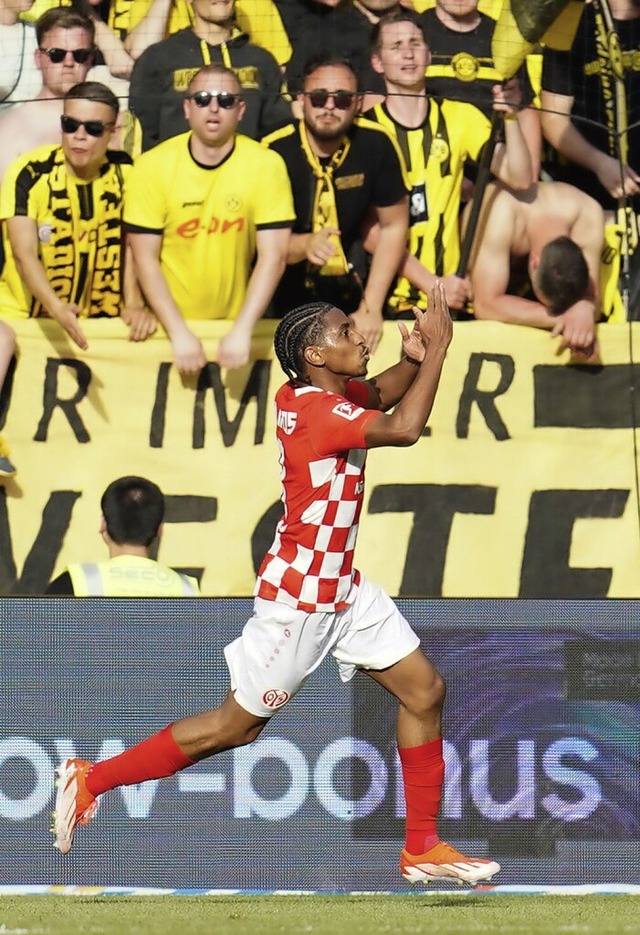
[{"xmin": 398, "ymin": 737, "xmax": 444, "ymax": 854}]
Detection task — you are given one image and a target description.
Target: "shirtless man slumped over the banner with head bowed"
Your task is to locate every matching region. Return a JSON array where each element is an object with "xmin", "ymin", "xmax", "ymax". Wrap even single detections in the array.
[{"xmin": 471, "ymin": 182, "xmax": 604, "ymax": 354}]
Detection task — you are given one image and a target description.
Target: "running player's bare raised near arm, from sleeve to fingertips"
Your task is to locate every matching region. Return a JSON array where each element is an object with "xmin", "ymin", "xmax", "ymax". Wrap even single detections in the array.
[{"xmin": 365, "ymin": 282, "xmax": 453, "ymax": 448}]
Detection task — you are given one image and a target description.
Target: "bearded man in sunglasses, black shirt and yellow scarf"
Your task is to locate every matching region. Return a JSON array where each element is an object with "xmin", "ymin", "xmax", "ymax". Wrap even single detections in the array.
[{"xmin": 263, "ymin": 57, "xmax": 408, "ymax": 351}]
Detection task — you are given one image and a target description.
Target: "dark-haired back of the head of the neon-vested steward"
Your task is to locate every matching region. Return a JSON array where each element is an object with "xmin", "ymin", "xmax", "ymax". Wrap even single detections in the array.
[{"xmin": 100, "ymin": 475, "xmax": 164, "ymax": 546}]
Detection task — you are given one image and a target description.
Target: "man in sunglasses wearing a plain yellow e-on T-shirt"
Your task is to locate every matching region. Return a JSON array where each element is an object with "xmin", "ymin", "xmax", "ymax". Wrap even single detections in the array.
[{"xmin": 124, "ymin": 65, "xmax": 293, "ymax": 375}]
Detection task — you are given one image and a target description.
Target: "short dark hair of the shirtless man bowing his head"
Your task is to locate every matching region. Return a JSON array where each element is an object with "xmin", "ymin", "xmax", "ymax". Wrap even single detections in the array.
[{"xmin": 536, "ymin": 236, "xmax": 589, "ymax": 315}]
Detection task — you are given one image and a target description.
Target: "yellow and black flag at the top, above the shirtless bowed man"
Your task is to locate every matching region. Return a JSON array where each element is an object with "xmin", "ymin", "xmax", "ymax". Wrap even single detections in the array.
[{"xmin": 491, "ymin": 0, "xmax": 584, "ymax": 79}]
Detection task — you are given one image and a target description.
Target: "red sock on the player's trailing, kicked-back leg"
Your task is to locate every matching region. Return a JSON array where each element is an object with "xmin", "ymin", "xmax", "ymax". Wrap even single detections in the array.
[{"xmin": 87, "ymin": 725, "xmax": 195, "ymax": 795}]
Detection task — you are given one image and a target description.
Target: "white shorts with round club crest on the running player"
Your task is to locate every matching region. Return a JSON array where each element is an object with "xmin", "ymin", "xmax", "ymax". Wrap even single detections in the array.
[{"xmin": 224, "ymin": 577, "xmax": 420, "ymax": 717}]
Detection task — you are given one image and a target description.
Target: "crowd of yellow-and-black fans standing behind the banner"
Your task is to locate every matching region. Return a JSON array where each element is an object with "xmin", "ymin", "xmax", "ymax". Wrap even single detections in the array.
[{"xmin": 0, "ymin": 0, "xmax": 640, "ymax": 476}]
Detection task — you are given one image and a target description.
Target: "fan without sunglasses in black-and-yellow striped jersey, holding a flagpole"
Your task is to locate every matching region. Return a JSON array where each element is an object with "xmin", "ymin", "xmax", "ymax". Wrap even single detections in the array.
[{"xmin": 366, "ymin": 10, "xmax": 531, "ymax": 315}]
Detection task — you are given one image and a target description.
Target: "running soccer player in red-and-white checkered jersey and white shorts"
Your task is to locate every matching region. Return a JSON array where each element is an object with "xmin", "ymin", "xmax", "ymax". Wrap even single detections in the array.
[{"xmin": 55, "ymin": 282, "xmax": 500, "ymax": 884}]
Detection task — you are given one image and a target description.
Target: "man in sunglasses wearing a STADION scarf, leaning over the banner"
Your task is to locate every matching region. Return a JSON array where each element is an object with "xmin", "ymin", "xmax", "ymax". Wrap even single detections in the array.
[{"xmin": 0, "ymin": 81, "xmax": 157, "ymax": 350}]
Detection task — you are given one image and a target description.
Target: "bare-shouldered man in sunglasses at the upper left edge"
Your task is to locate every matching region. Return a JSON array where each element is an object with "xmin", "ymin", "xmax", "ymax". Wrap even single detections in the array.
[{"xmin": 0, "ymin": 7, "xmax": 95, "ymax": 180}]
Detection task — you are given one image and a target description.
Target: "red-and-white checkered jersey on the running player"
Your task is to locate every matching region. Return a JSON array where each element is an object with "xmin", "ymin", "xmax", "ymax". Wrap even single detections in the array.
[{"xmin": 254, "ymin": 380, "xmax": 379, "ymax": 613}]
